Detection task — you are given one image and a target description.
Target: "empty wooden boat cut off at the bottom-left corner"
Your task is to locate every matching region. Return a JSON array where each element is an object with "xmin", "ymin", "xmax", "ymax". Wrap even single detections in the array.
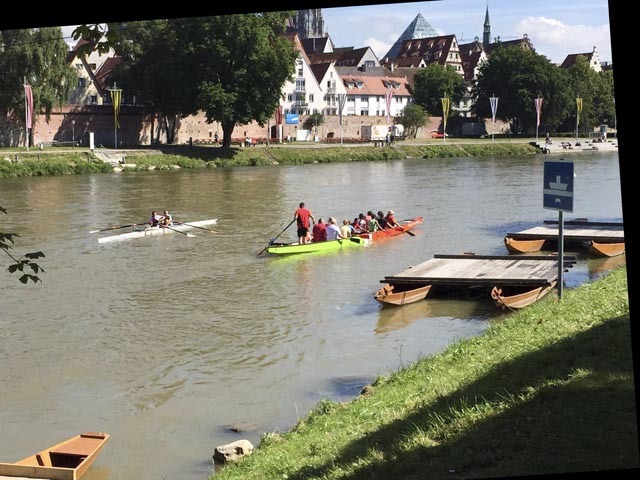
[{"xmin": 0, "ymin": 432, "xmax": 109, "ymax": 480}]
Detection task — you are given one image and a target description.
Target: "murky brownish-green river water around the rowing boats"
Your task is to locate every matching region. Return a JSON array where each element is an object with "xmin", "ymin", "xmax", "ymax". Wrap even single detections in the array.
[{"xmin": 0, "ymin": 152, "xmax": 624, "ymax": 480}]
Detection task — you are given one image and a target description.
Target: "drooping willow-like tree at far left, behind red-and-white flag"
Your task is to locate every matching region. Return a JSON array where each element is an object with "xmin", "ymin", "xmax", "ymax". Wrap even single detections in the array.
[{"xmin": 0, "ymin": 27, "xmax": 77, "ymax": 145}]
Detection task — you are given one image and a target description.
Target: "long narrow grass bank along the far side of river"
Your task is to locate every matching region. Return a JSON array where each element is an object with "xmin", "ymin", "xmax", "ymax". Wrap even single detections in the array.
[{"xmin": 0, "ymin": 142, "xmax": 539, "ymax": 177}]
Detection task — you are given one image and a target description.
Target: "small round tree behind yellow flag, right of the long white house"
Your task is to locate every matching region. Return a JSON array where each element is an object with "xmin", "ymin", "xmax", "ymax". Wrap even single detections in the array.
[{"xmin": 413, "ymin": 63, "xmax": 465, "ymax": 115}]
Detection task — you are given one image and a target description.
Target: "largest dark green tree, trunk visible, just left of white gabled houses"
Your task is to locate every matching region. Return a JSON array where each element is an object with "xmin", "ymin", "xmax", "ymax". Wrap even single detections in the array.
[{"xmin": 174, "ymin": 12, "xmax": 298, "ymax": 147}]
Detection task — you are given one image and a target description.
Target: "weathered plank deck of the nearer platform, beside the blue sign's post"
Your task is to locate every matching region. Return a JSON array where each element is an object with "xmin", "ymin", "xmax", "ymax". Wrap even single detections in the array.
[{"xmin": 380, "ymin": 254, "xmax": 576, "ymax": 288}]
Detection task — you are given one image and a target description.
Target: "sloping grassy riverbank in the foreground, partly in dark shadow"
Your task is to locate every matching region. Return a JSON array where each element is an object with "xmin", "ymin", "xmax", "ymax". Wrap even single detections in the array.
[{"xmin": 212, "ymin": 267, "xmax": 640, "ymax": 480}]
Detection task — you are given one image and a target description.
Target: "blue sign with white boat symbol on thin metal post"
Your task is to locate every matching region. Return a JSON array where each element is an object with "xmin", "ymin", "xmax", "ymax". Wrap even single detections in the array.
[{"xmin": 542, "ymin": 160, "xmax": 573, "ymax": 298}]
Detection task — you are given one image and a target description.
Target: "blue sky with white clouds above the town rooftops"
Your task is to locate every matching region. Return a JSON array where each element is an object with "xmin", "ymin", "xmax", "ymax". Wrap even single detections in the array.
[{"xmin": 322, "ymin": 0, "xmax": 612, "ymax": 63}]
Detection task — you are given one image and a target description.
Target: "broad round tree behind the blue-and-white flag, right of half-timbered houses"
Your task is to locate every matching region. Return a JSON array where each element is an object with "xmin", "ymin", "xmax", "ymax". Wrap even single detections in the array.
[{"xmin": 474, "ymin": 46, "xmax": 575, "ymax": 133}]
